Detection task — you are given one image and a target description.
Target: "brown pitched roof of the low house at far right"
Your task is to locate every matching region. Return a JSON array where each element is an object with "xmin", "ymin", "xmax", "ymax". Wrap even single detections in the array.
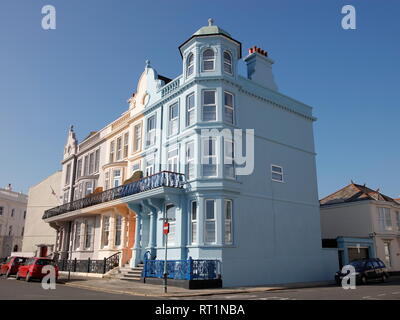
[{"xmin": 319, "ymin": 182, "xmax": 399, "ymax": 206}]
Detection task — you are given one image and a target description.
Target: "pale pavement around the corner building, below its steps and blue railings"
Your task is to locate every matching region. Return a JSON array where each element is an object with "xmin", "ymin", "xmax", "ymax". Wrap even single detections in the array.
[{"xmin": 60, "ymin": 276, "xmax": 332, "ymax": 299}]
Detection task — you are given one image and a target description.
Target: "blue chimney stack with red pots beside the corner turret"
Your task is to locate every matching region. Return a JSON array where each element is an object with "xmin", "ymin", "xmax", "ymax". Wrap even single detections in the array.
[{"xmin": 244, "ymin": 46, "xmax": 278, "ymax": 91}]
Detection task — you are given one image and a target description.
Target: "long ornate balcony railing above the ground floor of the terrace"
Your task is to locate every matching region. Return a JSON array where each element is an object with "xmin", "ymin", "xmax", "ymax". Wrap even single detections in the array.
[{"xmin": 43, "ymin": 171, "xmax": 185, "ymax": 219}]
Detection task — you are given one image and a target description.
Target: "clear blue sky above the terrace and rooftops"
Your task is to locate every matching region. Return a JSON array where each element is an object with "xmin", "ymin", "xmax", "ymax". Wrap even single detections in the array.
[{"xmin": 0, "ymin": 0, "xmax": 400, "ymax": 197}]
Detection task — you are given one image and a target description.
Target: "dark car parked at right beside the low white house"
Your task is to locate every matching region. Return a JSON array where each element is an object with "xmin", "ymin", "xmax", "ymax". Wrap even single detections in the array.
[{"xmin": 335, "ymin": 258, "xmax": 389, "ymax": 285}]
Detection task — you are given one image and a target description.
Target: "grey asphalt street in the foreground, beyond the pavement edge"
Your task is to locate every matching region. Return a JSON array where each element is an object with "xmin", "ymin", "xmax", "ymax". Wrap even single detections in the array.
[{"xmin": 0, "ymin": 277, "xmax": 400, "ymax": 300}]
